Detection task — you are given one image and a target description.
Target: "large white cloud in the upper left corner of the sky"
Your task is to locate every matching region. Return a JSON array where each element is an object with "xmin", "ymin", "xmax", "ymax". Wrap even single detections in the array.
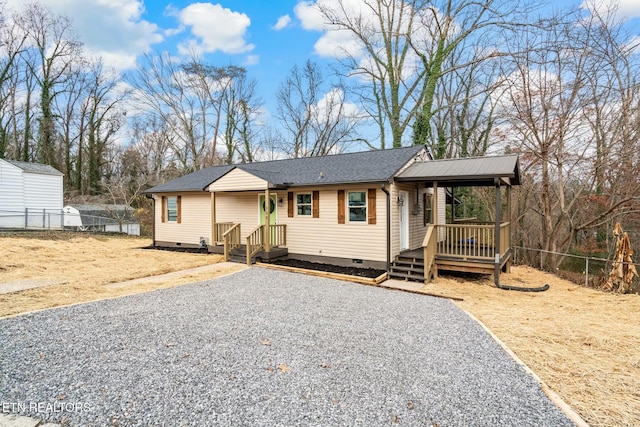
[{"xmin": 5, "ymin": 0, "xmax": 163, "ymax": 70}]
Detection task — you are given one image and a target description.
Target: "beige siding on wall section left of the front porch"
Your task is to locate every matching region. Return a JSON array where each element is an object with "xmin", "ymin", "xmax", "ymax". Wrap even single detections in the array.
[{"xmin": 154, "ymin": 192, "xmax": 211, "ymax": 245}]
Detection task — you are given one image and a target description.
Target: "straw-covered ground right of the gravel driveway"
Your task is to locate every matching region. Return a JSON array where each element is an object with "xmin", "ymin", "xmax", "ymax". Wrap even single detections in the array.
[{"xmin": 423, "ymin": 267, "xmax": 640, "ymax": 426}]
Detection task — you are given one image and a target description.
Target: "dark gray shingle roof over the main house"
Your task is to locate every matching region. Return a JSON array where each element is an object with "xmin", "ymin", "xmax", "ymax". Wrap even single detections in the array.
[{"xmin": 146, "ymin": 146, "xmax": 424, "ymax": 193}]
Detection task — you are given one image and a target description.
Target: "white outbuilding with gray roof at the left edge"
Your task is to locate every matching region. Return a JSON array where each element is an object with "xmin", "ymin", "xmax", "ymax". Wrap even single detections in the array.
[{"xmin": 0, "ymin": 159, "xmax": 64, "ymax": 230}]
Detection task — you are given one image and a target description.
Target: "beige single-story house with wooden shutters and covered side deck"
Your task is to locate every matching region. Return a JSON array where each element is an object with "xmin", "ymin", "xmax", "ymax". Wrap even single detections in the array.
[{"xmin": 146, "ymin": 146, "xmax": 520, "ymax": 282}]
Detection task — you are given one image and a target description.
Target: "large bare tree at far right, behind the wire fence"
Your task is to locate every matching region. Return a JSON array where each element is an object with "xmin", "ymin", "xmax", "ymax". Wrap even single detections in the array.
[{"xmin": 504, "ymin": 5, "xmax": 640, "ymax": 267}]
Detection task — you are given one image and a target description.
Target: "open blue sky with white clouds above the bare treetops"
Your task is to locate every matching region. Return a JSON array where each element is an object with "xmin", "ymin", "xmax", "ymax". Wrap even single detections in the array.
[{"xmin": 0, "ymin": 0, "xmax": 640, "ymax": 131}]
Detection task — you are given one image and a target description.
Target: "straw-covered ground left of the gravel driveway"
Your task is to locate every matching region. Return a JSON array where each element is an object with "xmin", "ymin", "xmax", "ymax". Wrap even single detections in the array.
[{"xmin": 0, "ymin": 232, "xmax": 241, "ymax": 317}]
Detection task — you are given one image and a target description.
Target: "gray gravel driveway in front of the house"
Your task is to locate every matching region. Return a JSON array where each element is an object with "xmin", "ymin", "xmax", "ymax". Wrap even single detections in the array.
[{"xmin": 0, "ymin": 267, "xmax": 572, "ymax": 427}]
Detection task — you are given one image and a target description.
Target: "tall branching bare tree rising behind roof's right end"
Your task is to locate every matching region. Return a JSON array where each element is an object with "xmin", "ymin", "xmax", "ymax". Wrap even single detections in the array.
[{"xmin": 315, "ymin": 0, "xmax": 521, "ymax": 148}]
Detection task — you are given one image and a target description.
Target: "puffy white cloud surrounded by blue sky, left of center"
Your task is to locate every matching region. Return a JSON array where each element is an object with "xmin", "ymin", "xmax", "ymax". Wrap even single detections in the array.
[{"xmin": 179, "ymin": 3, "xmax": 254, "ymax": 54}]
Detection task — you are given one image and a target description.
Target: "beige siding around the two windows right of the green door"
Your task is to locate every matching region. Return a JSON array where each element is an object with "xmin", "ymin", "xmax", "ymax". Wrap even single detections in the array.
[{"xmin": 278, "ymin": 184, "xmax": 387, "ymax": 261}]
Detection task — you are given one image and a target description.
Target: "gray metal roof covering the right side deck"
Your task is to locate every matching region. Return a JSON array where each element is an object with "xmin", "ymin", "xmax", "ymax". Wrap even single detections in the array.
[{"xmin": 396, "ymin": 154, "xmax": 520, "ymax": 187}]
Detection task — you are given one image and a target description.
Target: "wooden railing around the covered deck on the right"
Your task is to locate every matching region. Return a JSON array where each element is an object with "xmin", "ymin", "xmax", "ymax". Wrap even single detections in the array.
[{"xmin": 425, "ymin": 222, "xmax": 511, "ymax": 261}]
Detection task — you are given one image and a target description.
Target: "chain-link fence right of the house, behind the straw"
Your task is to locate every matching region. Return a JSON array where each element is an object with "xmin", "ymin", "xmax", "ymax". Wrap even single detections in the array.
[{"xmin": 513, "ymin": 246, "xmax": 640, "ymax": 293}]
